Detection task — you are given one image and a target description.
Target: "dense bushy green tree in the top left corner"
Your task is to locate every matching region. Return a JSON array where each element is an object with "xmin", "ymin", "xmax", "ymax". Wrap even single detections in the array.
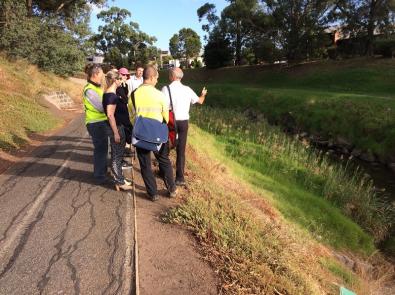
[{"xmin": 0, "ymin": 0, "xmax": 89, "ymax": 75}]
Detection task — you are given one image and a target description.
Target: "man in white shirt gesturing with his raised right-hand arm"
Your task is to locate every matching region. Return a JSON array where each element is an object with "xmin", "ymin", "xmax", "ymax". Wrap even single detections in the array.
[{"xmin": 162, "ymin": 68, "xmax": 207, "ymax": 186}]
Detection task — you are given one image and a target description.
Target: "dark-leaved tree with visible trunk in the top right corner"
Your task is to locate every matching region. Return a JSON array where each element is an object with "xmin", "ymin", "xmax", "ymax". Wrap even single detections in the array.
[{"xmin": 331, "ymin": 0, "xmax": 395, "ymax": 56}]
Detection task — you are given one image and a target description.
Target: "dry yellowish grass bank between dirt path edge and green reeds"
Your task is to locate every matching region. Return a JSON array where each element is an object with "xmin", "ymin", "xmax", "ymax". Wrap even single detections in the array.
[{"xmin": 167, "ymin": 126, "xmax": 392, "ymax": 294}]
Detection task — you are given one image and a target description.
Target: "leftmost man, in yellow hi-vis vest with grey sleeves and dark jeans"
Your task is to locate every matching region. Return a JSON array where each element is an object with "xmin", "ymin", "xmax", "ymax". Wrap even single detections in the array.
[{"xmin": 83, "ymin": 64, "xmax": 108, "ymax": 184}]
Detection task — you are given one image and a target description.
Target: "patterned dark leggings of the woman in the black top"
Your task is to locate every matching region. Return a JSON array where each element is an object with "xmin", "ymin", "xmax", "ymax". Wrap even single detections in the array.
[{"xmin": 107, "ymin": 124, "xmax": 126, "ymax": 184}]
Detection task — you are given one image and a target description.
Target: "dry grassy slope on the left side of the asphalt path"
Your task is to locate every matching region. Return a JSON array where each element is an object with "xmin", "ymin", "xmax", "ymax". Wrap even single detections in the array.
[{"xmin": 0, "ymin": 55, "xmax": 81, "ymax": 150}]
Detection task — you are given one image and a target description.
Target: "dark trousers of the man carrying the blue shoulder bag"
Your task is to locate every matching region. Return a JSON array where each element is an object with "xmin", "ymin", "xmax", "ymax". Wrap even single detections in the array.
[{"xmin": 136, "ymin": 142, "xmax": 176, "ymax": 197}]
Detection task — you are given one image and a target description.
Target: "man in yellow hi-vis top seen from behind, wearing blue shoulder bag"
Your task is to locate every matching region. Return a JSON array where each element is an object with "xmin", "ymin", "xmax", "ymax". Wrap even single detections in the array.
[{"xmin": 133, "ymin": 66, "xmax": 176, "ymax": 201}]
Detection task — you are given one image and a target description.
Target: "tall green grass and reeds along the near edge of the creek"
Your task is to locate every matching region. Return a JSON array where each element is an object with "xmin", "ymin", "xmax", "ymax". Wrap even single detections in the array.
[{"xmin": 192, "ymin": 107, "xmax": 395, "ymax": 247}]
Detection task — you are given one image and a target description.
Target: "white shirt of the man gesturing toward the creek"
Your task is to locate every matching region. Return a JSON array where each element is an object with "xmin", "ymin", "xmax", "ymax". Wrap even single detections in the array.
[{"xmin": 162, "ymin": 81, "xmax": 199, "ymax": 121}]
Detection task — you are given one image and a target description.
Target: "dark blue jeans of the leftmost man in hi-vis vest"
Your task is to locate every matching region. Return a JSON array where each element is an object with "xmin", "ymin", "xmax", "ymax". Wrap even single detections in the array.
[{"xmin": 86, "ymin": 121, "xmax": 108, "ymax": 182}]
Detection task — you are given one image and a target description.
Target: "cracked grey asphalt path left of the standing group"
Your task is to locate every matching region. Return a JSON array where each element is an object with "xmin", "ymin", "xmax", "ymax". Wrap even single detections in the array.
[{"xmin": 0, "ymin": 116, "xmax": 135, "ymax": 295}]
